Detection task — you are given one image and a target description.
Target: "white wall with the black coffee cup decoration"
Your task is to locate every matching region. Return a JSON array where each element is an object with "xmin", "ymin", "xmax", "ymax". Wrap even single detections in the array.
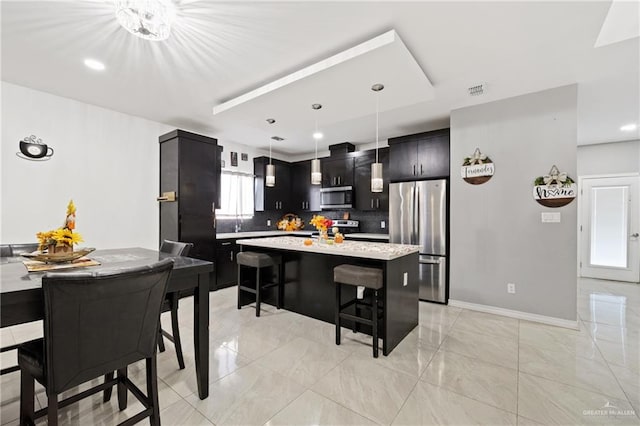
[{"xmin": 0, "ymin": 82, "xmax": 173, "ymax": 248}]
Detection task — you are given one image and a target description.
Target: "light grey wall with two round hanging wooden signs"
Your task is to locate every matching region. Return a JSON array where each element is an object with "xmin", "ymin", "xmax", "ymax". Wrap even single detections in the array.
[{"xmin": 450, "ymin": 85, "xmax": 577, "ymax": 321}]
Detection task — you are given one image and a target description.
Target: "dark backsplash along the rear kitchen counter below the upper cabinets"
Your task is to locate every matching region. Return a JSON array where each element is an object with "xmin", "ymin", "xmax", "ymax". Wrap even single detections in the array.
[{"xmin": 217, "ymin": 210, "xmax": 389, "ymax": 234}]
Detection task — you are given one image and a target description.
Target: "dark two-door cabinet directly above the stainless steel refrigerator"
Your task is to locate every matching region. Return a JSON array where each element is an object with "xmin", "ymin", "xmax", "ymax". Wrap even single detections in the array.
[{"xmin": 389, "ymin": 129, "xmax": 449, "ymax": 182}]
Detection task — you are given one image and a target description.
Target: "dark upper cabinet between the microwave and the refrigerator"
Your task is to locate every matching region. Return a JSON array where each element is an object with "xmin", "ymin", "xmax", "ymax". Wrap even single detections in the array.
[{"xmin": 355, "ymin": 148, "xmax": 389, "ymax": 211}]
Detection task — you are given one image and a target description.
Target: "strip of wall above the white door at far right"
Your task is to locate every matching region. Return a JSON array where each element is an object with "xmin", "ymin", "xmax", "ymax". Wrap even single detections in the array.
[{"xmin": 578, "ymin": 140, "xmax": 640, "ymax": 176}]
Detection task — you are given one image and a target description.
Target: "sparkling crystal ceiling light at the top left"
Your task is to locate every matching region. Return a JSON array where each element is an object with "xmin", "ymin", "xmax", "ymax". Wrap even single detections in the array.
[{"xmin": 116, "ymin": 0, "xmax": 174, "ymax": 41}]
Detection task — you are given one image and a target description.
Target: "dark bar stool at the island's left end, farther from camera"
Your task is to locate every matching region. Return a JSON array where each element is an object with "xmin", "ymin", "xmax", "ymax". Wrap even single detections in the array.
[{"xmin": 236, "ymin": 251, "xmax": 283, "ymax": 317}]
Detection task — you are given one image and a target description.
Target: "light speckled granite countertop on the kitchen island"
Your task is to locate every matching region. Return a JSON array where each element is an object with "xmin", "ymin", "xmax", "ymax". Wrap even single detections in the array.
[{"xmin": 236, "ymin": 236, "xmax": 419, "ymax": 260}]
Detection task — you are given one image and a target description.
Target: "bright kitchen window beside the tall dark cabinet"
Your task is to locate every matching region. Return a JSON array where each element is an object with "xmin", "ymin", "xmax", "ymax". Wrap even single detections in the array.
[{"xmin": 216, "ymin": 170, "xmax": 253, "ymax": 219}]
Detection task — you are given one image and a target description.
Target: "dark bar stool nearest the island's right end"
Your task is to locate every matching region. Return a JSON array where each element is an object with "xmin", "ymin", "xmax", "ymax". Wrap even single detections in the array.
[{"xmin": 333, "ymin": 265, "xmax": 384, "ymax": 358}]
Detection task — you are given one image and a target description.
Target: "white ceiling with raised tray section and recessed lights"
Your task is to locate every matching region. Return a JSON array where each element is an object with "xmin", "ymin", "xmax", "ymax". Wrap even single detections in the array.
[{"xmin": 1, "ymin": 0, "xmax": 640, "ymax": 155}]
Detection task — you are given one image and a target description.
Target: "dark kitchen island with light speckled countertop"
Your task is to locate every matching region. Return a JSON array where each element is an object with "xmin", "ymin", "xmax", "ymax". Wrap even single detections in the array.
[{"xmin": 236, "ymin": 236, "xmax": 418, "ymax": 355}]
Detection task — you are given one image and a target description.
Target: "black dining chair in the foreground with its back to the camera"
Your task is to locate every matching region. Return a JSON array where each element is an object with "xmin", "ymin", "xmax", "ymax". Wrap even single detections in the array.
[{"xmin": 18, "ymin": 259, "xmax": 173, "ymax": 426}]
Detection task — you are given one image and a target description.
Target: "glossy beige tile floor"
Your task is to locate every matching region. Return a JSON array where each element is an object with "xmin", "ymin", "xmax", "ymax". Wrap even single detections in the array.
[{"xmin": 0, "ymin": 279, "xmax": 640, "ymax": 425}]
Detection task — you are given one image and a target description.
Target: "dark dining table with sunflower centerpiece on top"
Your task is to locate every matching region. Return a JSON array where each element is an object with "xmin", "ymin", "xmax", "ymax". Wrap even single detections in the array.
[{"xmin": 0, "ymin": 248, "xmax": 214, "ymax": 399}]
